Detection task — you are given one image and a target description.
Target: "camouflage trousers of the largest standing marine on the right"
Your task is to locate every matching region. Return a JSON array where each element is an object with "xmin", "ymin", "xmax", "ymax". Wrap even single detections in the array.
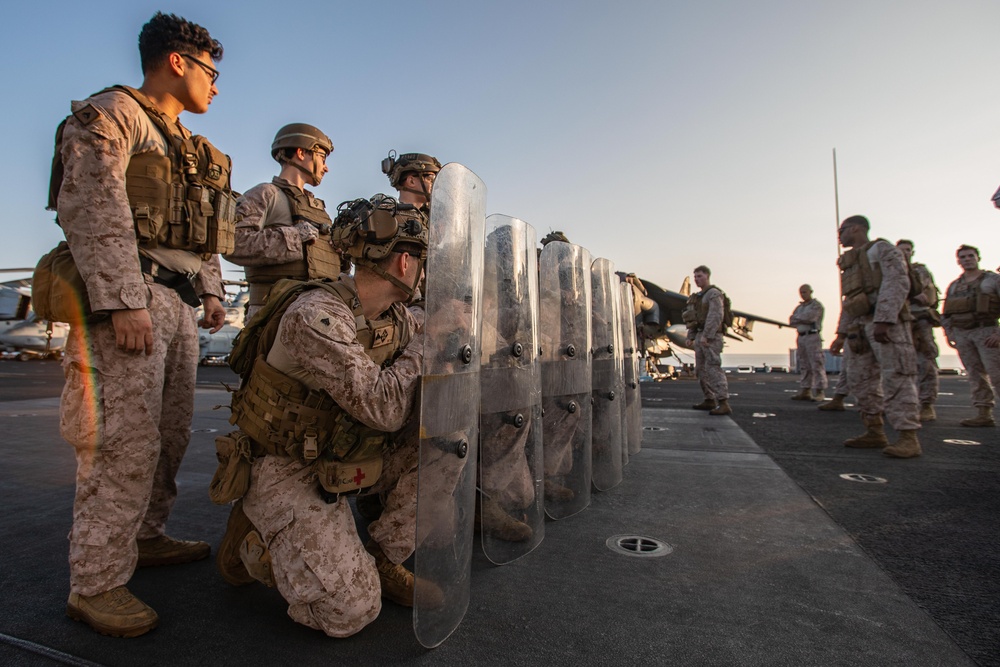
[{"xmin": 847, "ymin": 317, "xmax": 920, "ymax": 431}]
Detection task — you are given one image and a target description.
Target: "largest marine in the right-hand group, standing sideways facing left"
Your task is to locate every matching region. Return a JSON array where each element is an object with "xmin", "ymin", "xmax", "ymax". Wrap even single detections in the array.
[{"xmin": 830, "ymin": 215, "xmax": 921, "ymax": 458}]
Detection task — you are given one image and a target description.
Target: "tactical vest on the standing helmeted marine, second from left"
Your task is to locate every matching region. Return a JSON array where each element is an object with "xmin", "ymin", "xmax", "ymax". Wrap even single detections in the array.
[{"xmin": 246, "ymin": 183, "xmax": 341, "ymax": 306}]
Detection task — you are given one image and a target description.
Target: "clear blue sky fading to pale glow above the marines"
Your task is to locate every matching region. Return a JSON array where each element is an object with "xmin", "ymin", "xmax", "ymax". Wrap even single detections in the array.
[{"xmin": 0, "ymin": 0, "xmax": 1000, "ymax": 354}]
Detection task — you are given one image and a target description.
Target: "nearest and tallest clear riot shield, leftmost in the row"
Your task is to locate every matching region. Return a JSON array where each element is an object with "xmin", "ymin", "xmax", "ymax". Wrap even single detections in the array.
[{"xmin": 413, "ymin": 163, "xmax": 486, "ymax": 648}]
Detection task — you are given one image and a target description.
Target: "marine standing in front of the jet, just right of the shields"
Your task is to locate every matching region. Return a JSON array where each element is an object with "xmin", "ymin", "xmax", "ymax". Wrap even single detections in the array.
[{"xmin": 684, "ymin": 266, "xmax": 732, "ymax": 415}]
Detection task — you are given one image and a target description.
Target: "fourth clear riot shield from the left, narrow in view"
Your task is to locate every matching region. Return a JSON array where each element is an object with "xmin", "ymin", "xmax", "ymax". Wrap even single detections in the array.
[{"xmin": 590, "ymin": 258, "xmax": 626, "ymax": 491}]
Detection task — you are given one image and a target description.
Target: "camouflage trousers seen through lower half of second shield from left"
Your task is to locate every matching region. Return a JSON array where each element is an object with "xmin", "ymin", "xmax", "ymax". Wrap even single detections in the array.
[{"xmin": 479, "ymin": 405, "xmax": 542, "ymax": 511}]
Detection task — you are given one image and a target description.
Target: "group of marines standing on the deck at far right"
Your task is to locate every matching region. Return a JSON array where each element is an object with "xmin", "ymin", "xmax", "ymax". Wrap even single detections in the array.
[{"xmin": 789, "ymin": 215, "xmax": 1000, "ymax": 458}]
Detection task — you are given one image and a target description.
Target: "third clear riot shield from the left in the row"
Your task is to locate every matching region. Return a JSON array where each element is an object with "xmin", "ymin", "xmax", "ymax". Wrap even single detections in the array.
[{"xmin": 538, "ymin": 241, "xmax": 593, "ymax": 519}]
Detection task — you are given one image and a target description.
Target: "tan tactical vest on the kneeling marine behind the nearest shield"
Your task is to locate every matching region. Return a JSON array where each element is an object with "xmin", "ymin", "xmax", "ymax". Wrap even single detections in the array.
[{"xmin": 230, "ymin": 281, "xmax": 410, "ymax": 494}]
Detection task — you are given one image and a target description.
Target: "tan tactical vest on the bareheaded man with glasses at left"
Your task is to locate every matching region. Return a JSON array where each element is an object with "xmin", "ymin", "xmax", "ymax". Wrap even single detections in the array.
[{"xmin": 49, "ymin": 86, "xmax": 236, "ymax": 254}]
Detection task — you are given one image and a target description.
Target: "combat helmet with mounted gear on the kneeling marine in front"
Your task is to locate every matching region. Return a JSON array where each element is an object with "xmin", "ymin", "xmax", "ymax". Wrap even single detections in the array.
[{"xmin": 330, "ymin": 195, "xmax": 428, "ymax": 297}]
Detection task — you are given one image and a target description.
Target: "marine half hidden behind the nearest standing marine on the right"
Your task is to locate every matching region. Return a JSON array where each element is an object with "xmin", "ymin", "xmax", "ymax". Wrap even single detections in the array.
[{"xmin": 896, "ymin": 239, "xmax": 941, "ymax": 422}]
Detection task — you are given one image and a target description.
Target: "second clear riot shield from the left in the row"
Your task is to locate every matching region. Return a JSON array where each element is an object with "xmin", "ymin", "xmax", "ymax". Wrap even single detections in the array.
[{"xmin": 479, "ymin": 215, "xmax": 545, "ymax": 565}]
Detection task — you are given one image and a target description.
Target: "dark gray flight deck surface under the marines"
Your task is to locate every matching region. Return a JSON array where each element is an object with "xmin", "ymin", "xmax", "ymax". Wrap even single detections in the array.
[{"xmin": 0, "ymin": 362, "xmax": 988, "ymax": 665}]
